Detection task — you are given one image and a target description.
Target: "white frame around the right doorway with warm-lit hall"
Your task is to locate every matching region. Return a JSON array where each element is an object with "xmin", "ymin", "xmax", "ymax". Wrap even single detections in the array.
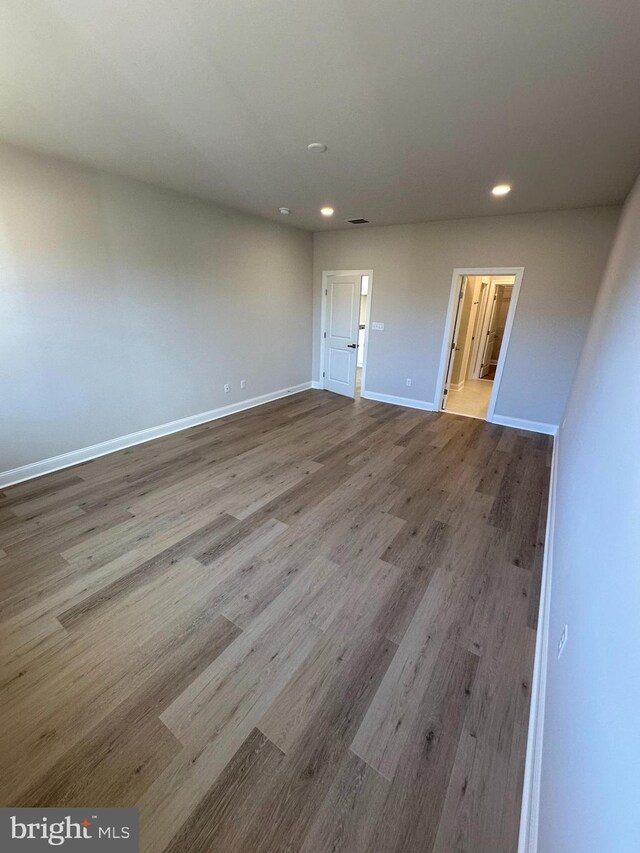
[{"xmin": 434, "ymin": 267, "xmax": 524, "ymax": 423}]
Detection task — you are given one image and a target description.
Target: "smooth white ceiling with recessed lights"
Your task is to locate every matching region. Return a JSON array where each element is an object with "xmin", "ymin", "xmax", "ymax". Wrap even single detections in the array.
[{"xmin": 0, "ymin": 0, "xmax": 640, "ymax": 230}]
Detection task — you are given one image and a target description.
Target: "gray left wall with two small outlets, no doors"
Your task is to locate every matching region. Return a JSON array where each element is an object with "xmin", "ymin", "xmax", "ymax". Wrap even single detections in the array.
[{"xmin": 0, "ymin": 146, "xmax": 312, "ymax": 471}]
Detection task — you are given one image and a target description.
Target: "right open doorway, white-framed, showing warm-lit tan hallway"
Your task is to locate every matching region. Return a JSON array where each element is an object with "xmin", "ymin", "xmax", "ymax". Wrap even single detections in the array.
[{"xmin": 439, "ymin": 269, "xmax": 522, "ymax": 420}]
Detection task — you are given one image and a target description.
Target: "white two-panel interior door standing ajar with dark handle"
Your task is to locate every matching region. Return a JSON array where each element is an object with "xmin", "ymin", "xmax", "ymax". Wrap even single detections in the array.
[{"xmin": 322, "ymin": 275, "xmax": 361, "ymax": 397}]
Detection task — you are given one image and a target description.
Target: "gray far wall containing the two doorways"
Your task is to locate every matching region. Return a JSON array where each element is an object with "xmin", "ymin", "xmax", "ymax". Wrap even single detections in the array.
[{"xmin": 313, "ymin": 207, "xmax": 620, "ymax": 424}]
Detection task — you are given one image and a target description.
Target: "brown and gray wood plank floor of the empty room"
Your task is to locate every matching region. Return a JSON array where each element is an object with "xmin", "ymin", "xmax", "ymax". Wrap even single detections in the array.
[{"xmin": 0, "ymin": 391, "xmax": 551, "ymax": 853}]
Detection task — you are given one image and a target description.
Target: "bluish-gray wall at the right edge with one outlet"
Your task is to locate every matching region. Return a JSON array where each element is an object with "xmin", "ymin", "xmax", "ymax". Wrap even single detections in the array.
[{"xmin": 538, "ymin": 176, "xmax": 640, "ymax": 853}]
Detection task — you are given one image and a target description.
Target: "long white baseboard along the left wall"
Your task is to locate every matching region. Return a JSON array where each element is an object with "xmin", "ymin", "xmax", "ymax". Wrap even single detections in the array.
[{"xmin": 0, "ymin": 382, "xmax": 312, "ymax": 489}]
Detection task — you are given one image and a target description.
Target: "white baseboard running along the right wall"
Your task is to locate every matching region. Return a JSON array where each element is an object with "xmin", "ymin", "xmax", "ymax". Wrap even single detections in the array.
[{"xmin": 518, "ymin": 436, "xmax": 559, "ymax": 853}]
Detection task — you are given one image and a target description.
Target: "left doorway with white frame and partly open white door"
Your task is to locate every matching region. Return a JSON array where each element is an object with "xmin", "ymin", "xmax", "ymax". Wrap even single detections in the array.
[{"xmin": 320, "ymin": 270, "xmax": 373, "ymax": 398}]
